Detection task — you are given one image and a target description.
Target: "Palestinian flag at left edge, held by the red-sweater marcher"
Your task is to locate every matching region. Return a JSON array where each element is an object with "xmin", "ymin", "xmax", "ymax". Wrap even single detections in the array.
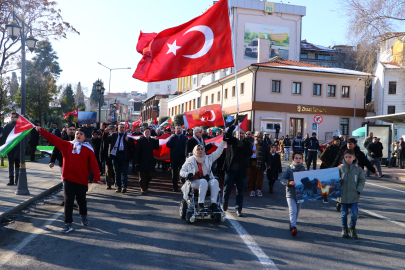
[{"xmin": 0, "ymin": 115, "xmax": 34, "ymax": 157}]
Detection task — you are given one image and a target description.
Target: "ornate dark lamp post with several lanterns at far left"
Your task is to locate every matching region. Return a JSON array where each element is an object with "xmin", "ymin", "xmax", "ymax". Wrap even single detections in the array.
[{"xmin": 6, "ymin": 10, "xmax": 38, "ymax": 195}]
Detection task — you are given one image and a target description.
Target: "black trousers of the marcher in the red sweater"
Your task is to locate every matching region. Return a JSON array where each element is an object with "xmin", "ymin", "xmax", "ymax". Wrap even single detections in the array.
[{"xmin": 63, "ymin": 179, "xmax": 89, "ymax": 223}]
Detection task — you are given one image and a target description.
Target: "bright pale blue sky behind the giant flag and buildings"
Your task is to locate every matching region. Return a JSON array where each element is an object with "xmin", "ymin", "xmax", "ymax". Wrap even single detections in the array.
[{"xmin": 43, "ymin": 0, "xmax": 347, "ymax": 95}]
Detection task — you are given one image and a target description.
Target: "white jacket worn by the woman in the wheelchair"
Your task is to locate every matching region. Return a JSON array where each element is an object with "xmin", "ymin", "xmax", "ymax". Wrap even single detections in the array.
[{"xmin": 180, "ymin": 141, "xmax": 225, "ymax": 200}]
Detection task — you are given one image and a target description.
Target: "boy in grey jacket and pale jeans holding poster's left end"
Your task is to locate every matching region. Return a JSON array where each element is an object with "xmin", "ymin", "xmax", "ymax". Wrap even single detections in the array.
[{"xmin": 280, "ymin": 152, "xmax": 305, "ymax": 236}]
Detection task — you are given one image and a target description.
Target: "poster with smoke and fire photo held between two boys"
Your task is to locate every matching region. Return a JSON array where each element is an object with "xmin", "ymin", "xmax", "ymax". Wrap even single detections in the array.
[{"xmin": 293, "ymin": 168, "xmax": 342, "ymax": 203}]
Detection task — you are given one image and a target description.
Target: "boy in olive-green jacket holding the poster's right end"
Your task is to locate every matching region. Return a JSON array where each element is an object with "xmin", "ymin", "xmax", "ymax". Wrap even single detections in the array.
[{"xmin": 339, "ymin": 149, "xmax": 366, "ymax": 239}]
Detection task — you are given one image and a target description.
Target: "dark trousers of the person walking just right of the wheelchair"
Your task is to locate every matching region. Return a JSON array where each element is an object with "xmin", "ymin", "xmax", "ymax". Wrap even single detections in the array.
[{"xmin": 223, "ymin": 169, "xmax": 247, "ymax": 212}]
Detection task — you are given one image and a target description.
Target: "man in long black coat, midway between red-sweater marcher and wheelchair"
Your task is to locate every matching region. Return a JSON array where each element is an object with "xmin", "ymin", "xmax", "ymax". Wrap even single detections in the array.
[{"xmin": 135, "ymin": 128, "xmax": 159, "ymax": 195}]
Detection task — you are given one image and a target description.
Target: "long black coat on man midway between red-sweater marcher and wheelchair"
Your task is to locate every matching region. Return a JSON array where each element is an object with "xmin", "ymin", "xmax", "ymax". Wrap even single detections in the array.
[{"xmin": 134, "ymin": 136, "xmax": 159, "ymax": 172}]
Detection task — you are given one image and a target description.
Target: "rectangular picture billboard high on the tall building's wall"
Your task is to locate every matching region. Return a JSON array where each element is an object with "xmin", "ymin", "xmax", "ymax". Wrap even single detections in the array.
[{"xmin": 243, "ymin": 23, "xmax": 290, "ymax": 60}]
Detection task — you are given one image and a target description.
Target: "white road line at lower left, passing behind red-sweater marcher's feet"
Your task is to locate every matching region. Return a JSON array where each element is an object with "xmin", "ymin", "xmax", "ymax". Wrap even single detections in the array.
[{"xmin": 0, "ymin": 184, "xmax": 96, "ymax": 269}]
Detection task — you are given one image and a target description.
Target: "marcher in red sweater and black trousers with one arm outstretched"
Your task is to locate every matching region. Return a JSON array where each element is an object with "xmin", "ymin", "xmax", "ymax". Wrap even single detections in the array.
[{"xmin": 36, "ymin": 127, "xmax": 102, "ymax": 233}]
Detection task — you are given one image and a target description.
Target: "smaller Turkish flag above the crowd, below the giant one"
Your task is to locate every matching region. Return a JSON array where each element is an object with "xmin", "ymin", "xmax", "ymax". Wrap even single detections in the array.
[{"xmin": 184, "ymin": 104, "xmax": 225, "ymax": 128}]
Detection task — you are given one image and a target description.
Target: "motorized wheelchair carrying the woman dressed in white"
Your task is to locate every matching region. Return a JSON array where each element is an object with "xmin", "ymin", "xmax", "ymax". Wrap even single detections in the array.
[{"xmin": 179, "ymin": 178, "xmax": 226, "ymax": 224}]
